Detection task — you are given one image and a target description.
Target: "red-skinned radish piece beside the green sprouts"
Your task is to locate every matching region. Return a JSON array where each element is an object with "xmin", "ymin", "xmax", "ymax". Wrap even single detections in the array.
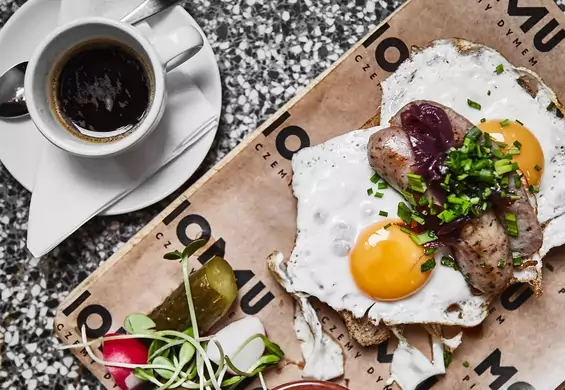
[{"xmin": 102, "ymin": 333, "xmax": 149, "ymax": 390}]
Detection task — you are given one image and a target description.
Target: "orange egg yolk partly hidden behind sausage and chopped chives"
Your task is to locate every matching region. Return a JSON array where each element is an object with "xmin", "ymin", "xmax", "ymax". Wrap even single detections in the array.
[{"xmin": 478, "ymin": 120, "xmax": 544, "ymax": 185}]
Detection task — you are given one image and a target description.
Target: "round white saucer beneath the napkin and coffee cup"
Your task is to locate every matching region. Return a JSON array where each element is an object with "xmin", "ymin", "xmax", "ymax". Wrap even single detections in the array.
[{"xmin": 0, "ymin": 0, "xmax": 222, "ymax": 215}]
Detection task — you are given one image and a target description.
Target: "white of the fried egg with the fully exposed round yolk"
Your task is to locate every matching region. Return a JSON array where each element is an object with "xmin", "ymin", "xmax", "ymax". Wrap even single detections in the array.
[{"xmin": 287, "ymin": 127, "xmax": 488, "ymax": 326}]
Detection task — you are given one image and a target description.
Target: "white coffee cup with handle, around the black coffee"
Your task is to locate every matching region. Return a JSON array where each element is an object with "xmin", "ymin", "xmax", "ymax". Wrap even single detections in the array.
[{"xmin": 25, "ymin": 6, "xmax": 203, "ymax": 157}]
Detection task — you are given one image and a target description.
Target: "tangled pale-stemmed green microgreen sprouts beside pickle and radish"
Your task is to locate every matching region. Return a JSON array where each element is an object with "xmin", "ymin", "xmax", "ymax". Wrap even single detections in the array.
[{"xmin": 61, "ymin": 240, "xmax": 284, "ymax": 390}]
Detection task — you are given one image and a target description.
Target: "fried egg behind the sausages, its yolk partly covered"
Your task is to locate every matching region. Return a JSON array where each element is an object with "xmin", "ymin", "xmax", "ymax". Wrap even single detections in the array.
[{"xmin": 381, "ymin": 40, "xmax": 565, "ymax": 283}]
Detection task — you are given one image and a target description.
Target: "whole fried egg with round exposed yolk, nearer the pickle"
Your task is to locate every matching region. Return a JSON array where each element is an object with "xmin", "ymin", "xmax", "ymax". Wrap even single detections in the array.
[{"xmin": 287, "ymin": 128, "xmax": 488, "ymax": 327}]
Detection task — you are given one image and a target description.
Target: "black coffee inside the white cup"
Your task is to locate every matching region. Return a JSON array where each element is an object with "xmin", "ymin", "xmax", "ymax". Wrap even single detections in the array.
[{"xmin": 53, "ymin": 41, "xmax": 152, "ymax": 142}]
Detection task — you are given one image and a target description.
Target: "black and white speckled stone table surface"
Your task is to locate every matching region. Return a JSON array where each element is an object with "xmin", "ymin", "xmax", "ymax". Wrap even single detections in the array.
[{"xmin": 0, "ymin": 0, "xmax": 565, "ymax": 390}]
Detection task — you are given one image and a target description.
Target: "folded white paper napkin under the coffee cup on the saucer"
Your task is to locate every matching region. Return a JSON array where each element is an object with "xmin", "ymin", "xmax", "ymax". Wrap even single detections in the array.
[{"xmin": 27, "ymin": 4, "xmax": 217, "ymax": 257}]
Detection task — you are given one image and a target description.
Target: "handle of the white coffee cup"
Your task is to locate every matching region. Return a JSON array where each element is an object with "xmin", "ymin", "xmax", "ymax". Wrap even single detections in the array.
[{"xmin": 135, "ymin": 9, "xmax": 204, "ymax": 72}]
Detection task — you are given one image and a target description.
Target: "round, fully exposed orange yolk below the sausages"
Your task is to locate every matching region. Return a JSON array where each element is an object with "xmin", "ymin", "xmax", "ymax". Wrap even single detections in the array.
[{"xmin": 349, "ymin": 219, "xmax": 431, "ymax": 301}]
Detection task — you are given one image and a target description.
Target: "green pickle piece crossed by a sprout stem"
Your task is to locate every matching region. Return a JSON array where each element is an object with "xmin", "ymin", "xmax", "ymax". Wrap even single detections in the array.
[{"xmin": 149, "ymin": 256, "xmax": 237, "ymax": 333}]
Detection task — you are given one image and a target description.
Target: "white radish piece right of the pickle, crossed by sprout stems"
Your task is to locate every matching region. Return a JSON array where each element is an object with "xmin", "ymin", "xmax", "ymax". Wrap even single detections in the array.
[{"xmin": 206, "ymin": 317, "xmax": 265, "ymax": 374}]
